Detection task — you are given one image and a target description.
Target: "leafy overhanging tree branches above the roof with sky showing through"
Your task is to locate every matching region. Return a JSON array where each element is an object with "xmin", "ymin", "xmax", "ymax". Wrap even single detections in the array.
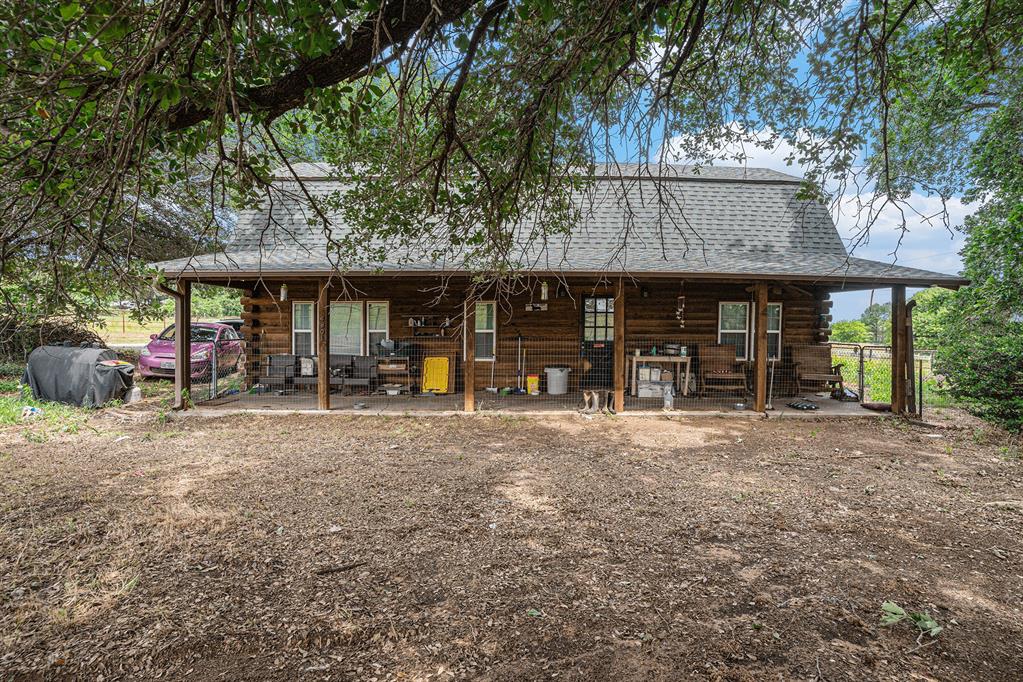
[{"xmin": 0, "ymin": 0, "xmax": 1020, "ymax": 316}]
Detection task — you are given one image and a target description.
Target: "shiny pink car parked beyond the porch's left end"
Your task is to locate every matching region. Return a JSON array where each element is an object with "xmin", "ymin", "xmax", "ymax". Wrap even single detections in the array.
[{"xmin": 138, "ymin": 322, "xmax": 241, "ymax": 378}]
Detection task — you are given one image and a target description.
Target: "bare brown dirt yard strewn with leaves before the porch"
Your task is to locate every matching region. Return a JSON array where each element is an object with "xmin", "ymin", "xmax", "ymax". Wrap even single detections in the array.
[{"xmin": 0, "ymin": 411, "xmax": 1023, "ymax": 680}]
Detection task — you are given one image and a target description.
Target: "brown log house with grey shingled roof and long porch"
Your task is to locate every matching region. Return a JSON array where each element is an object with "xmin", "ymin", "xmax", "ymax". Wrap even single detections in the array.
[{"xmin": 151, "ymin": 164, "xmax": 967, "ymax": 412}]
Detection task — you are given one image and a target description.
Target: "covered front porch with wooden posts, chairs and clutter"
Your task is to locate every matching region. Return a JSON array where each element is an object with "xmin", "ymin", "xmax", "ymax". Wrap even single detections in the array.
[{"xmin": 165, "ymin": 277, "xmax": 914, "ymax": 416}]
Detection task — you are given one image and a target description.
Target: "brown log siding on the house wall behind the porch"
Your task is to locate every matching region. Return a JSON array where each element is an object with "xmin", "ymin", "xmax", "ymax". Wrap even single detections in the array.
[{"xmin": 233, "ymin": 276, "xmax": 831, "ymax": 390}]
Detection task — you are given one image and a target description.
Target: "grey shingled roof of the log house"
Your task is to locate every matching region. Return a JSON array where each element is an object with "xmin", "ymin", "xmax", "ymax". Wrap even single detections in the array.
[{"xmin": 157, "ymin": 164, "xmax": 966, "ymax": 286}]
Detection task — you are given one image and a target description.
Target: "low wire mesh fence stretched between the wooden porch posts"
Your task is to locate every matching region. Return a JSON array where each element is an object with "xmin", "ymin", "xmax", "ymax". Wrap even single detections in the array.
[{"xmin": 182, "ymin": 335, "xmax": 920, "ymax": 413}]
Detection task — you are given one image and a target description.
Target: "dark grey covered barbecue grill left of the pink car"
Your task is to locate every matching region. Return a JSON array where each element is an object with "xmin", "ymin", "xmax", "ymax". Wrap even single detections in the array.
[{"xmin": 21, "ymin": 346, "xmax": 135, "ymax": 407}]
